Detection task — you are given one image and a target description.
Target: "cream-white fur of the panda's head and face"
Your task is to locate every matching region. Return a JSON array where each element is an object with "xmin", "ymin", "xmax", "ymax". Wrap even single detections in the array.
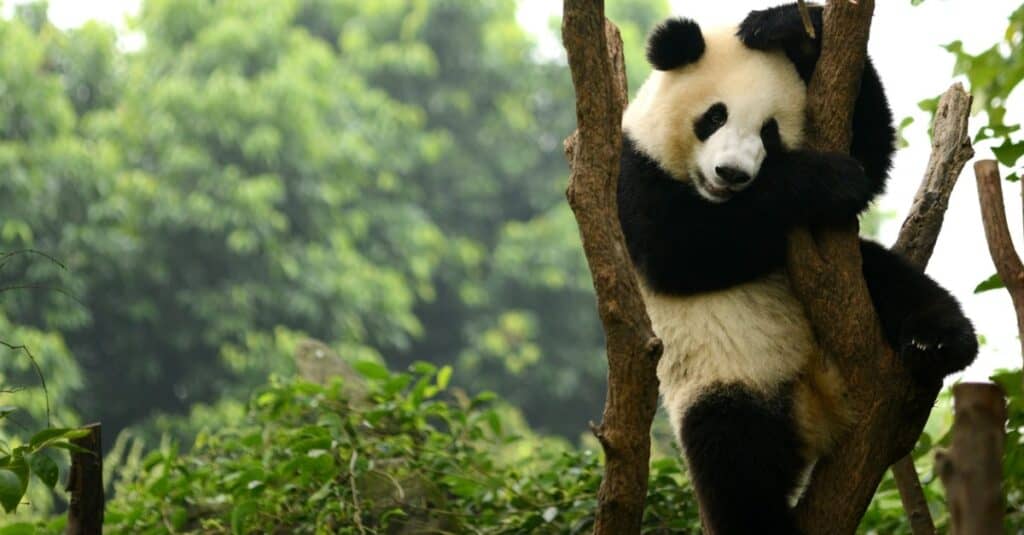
[{"xmin": 623, "ymin": 27, "xmax": 807, "ymax": 184}]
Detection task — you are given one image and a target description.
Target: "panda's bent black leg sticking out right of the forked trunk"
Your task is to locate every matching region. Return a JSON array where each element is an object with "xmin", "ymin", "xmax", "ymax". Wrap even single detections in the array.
[{"xmin": 860, "ymin": 240, "xmax": 978, "ymax": 381}]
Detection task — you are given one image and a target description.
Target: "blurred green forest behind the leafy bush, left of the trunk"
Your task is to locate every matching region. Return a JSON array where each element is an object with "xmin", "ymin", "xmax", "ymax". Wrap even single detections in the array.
[{"xmin": 0, "ymin": 0, "xmax": 668, "ymax": 438}]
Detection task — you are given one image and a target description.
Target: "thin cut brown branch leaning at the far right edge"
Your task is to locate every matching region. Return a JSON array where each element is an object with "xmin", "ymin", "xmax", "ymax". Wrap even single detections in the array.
[{"xmin": 974, "ymin": 160, "xmax": 1024, "ymax": 371}]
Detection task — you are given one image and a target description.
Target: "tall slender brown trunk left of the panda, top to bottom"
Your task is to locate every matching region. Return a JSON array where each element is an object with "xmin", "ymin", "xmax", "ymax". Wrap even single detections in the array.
[{"xmin": 562, "ymin": 0, "xmax": 662, "ymax": 535}]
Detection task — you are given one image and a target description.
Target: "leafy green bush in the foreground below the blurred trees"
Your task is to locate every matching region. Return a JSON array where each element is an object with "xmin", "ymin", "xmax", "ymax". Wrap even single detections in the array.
[{"xmin": 105, "ymin": 361, "xmax": 698, "ymax": 533}]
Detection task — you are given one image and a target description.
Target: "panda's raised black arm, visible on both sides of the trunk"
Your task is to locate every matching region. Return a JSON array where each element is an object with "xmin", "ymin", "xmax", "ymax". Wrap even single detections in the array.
[{"xmin": 736, "ymin": 4, "xmax": 896, "ymax": 187}]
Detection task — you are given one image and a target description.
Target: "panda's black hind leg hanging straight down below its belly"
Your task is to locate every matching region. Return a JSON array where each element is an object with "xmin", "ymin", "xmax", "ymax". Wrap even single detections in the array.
[{"xmin": 680, "ymin": 385, "xmax": 807, "ymax": 535}]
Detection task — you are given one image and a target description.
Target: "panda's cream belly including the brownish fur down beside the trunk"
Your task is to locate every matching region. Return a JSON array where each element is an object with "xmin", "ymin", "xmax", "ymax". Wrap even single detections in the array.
[{"xmin": 644, "ymin": 271, "xmax": 850, "ymax": 459}]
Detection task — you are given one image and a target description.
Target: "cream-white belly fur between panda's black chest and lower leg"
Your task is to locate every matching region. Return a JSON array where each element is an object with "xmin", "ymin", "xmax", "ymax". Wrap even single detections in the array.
[{"xmin": 644, "ymin": 272, "xmax": 819, "ymax": 437}]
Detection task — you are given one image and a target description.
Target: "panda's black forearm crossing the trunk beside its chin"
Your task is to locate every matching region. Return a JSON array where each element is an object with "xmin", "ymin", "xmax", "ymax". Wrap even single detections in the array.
[{"xmin": 735, "ymin": 150, "xmax": 884, "ymax": 227}]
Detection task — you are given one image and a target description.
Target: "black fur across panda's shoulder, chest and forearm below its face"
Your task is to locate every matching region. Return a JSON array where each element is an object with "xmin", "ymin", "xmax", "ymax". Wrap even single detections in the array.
[{"xmin": 618, "ymin": 134, "xmax": 884, "ymax": 295}]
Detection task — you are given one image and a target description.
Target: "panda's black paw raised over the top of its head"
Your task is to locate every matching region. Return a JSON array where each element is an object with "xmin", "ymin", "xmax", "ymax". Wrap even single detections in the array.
[{"xmin": 736, "ymin": 3, "xmax": 824, "ymax": 82}]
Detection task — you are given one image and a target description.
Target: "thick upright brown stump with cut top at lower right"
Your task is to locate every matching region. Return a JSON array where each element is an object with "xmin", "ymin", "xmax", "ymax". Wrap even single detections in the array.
[{"xmin": 935, "ymin": 382, "xmax": 1007, "ymax": 535}]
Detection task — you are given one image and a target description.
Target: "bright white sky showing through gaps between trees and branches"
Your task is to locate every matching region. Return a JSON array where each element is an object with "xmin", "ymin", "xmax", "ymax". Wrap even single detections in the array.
[{"xmin": 14, "ymin": 0, "xmax": 1024, "ymax": 380}]
